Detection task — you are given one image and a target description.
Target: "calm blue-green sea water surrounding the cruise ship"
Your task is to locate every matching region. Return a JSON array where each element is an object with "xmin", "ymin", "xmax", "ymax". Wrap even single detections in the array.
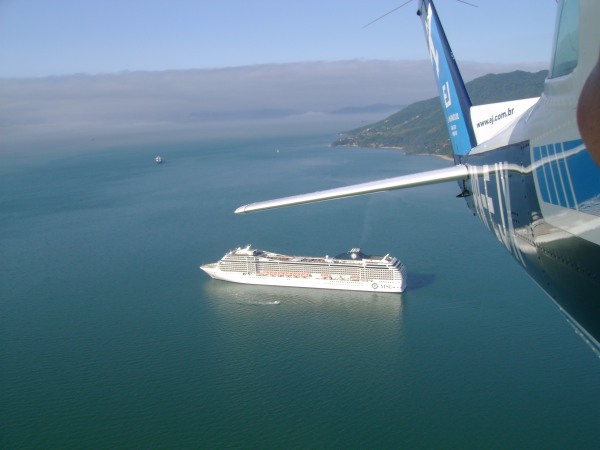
[{"xmin": 0, "ymin": 124, "xmax": 600, "ymax": 449}]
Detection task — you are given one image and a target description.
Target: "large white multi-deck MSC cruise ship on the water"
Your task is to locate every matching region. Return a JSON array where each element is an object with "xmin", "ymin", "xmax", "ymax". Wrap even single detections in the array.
[{"xmin": 200, "ymin": 245, "xmax": 406, "ymax": 292}]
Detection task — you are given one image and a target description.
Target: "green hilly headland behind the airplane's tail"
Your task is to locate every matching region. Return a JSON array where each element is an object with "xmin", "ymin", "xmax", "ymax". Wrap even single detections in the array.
[{"xmin": 332, "ymin": 70, "xmax": 548, "ymax": 156}]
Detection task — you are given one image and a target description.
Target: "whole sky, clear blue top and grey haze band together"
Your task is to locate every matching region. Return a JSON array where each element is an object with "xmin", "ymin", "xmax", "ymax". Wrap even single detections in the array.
[{"xmin": 0, "ymin": 0, "xmax": 556, "ymax": 152}]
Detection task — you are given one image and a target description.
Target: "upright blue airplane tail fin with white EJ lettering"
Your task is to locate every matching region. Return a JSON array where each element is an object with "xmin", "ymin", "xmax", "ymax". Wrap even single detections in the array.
[{"xmin": 418, "ymin": 0, "xmax": 476, "ymax": 164}]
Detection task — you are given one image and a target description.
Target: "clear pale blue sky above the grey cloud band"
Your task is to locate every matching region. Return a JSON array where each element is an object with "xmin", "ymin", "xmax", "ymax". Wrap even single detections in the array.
[{"xmin": 0, "ymin": 0, "xmax": 556, "ymax": 77}]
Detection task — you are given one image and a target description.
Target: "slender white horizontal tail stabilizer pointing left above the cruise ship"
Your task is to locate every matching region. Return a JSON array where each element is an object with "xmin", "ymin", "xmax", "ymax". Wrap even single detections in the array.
[{"xmin": 235, "ymin": 164, "xmax": 469, "ymax": 214}]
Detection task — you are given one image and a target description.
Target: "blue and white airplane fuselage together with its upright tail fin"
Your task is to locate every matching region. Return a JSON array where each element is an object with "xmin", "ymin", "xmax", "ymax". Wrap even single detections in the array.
[{"xmin": 419, "ymin": 0, "xmax": 600, "ymax": 353}]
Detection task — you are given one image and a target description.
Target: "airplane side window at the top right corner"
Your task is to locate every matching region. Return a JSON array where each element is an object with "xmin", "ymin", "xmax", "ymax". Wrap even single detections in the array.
[{"xmin": 552, "ymin": 0, "xmax": 579, "ymax": 78}]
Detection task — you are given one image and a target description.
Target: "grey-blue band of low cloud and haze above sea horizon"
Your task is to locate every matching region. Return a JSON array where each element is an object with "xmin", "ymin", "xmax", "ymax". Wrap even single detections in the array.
[{"xmin": 0, "ymin": 60, "xmax": 543, "ymax": 149}]
